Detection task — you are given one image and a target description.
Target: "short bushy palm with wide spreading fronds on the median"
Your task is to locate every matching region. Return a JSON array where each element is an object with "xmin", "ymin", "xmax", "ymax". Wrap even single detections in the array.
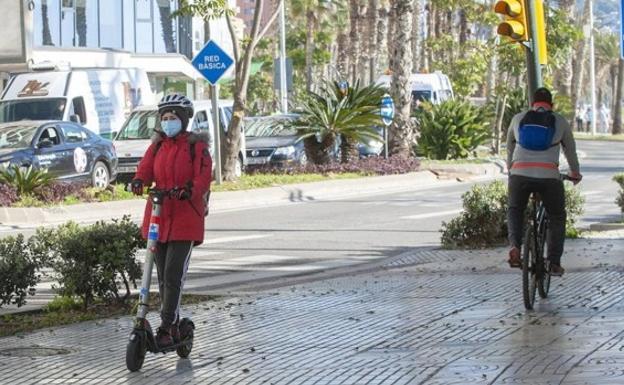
[{"xmin": 293, "ymin": 82, "xmax": 384, "ymax": 164}]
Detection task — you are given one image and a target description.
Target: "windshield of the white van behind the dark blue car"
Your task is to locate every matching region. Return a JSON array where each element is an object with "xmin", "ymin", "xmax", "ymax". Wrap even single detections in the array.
[{"xmin": 0, "ymin": 98, "xmax": 67, "ymax": 123}]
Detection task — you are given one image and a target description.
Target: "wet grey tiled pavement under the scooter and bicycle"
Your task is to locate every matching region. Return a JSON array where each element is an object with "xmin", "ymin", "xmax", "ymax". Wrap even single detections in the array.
[{"xmin": 0, "ymin": 232, "xmax": 624, "ymax": 385}]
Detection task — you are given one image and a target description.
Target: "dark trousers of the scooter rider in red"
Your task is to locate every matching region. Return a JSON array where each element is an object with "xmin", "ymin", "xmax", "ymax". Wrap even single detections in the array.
[{"xmin": 154, "ymin": 241, "xmax": 193, "ymax": 328}]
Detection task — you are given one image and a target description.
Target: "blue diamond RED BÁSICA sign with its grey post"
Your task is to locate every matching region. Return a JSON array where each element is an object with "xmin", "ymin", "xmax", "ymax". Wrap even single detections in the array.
[{"xmin": 193, "ymin": 40, "xmax": 234, "ymax": 184}]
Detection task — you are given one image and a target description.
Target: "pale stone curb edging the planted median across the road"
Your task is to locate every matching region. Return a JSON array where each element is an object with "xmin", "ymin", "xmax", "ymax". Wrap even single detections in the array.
[{"xmin": 0, "ymin": 163, "xmax": 502, "ymax": 228}]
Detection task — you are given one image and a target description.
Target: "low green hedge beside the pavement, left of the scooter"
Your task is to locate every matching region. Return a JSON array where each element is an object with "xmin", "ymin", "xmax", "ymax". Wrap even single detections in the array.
[{"xmin": 0, "ymin": 216, "xmax": 145, "ymax": 308}]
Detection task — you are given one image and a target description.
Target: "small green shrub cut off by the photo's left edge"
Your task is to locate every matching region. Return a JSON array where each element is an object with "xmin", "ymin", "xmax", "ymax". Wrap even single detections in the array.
[{"xmin": 0, "ymin": 234, "xmax": 41, "ymax": 307}]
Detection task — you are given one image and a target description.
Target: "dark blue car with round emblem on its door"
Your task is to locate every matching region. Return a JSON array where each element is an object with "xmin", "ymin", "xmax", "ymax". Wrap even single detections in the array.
[{"xmin": 0, "ymin": 120, "xmax": 117, "ymax": 188}]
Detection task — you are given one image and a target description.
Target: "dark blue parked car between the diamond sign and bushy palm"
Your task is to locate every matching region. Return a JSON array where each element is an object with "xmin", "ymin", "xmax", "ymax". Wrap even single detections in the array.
[{"xmin": 245, "ymin": 114, "xmax": 308, "ymax": 167}]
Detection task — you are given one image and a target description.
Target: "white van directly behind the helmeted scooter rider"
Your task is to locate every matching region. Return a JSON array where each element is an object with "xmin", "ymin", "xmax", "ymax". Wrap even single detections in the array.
[{"xmin": 113, "ymin": 100, "xmax": 247, "ymax": 179}]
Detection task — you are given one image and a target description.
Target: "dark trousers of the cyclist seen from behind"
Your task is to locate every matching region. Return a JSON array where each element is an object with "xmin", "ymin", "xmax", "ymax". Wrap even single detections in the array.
[{"xmin": 507, "ymin": 175, "xmax": 566, "ymax": 264}]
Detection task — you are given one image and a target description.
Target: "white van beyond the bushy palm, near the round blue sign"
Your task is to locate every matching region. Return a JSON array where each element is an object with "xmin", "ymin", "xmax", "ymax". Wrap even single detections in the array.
[{"xmin": 377, "ymin": 71, "xmax": 455, "ymax": 105}]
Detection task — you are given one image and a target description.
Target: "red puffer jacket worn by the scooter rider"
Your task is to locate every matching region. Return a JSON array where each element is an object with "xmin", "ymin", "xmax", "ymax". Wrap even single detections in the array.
[{"xmin": 135, "ymin": 132, "xmax": 212, "ymax": 245}]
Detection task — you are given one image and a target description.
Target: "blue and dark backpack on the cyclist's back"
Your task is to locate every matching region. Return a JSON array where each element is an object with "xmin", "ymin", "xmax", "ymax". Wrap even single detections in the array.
[{"xmin": 518, "ymin": 110, "xmax": 559, "ymax": 151}]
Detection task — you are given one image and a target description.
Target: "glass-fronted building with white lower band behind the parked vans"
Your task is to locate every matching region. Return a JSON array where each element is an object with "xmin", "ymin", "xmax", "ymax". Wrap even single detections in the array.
[{"xmin": 0, "ymin": 0, "xmax": 235, "ymax": 97}]
